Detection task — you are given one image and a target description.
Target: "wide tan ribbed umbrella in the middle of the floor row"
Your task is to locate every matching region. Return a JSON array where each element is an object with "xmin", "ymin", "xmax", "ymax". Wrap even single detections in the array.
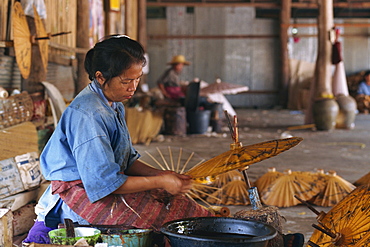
[{"xmin": 261, "ymin": 169, "xmax": 321, "ymax": 207}]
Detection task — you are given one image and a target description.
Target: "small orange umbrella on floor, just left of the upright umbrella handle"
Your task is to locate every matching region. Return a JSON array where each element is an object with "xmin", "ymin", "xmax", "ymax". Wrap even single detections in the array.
[{"xmin": 207, "ymin": 178, "xmax": 250, "ymax": 205}]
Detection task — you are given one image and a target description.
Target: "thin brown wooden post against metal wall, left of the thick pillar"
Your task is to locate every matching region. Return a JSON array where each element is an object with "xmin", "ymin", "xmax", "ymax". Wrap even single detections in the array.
[{"xmin": 279, "ymin": 0, "xmax": 291, "ymax": 108}]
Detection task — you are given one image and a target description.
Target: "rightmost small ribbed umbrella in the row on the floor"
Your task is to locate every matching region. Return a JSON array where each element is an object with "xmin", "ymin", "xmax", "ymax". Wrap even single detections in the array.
[{"xmin": 312, "ymin": 171, "xmax": 356, "ymax": 207}]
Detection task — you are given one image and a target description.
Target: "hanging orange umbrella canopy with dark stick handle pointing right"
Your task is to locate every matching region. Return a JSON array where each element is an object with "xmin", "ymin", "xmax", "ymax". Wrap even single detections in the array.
[{"xmin": 33, "ymin": 5, "xmax": 49, "ymax": 73}]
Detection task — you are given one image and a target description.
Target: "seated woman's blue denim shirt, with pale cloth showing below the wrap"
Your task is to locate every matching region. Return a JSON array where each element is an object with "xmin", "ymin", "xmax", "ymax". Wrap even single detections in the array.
[{"xmin": 38, "ymin": 81, "xmax": 140, "ymax": 224}]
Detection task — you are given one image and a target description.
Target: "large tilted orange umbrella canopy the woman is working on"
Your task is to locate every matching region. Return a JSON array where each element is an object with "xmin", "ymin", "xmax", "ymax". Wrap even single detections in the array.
[{"xmin": 185, "ymin": 137, "xmax": 303, "ymax": 179}]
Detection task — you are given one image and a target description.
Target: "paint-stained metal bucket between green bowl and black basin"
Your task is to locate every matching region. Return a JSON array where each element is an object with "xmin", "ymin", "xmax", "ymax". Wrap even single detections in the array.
[{"xmin": 101, "ymin": 229, "xmax": 153, "ymax": 247}]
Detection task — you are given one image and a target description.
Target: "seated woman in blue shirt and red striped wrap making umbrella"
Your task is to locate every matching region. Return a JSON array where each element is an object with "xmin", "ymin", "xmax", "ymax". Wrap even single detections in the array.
[{"xmin": 24, "ymin": 36, "xmax": 209, "ymax": 243}]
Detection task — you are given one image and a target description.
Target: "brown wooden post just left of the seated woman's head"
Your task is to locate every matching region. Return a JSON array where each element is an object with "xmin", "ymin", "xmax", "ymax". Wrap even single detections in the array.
[{"xmin": 75, "ymin": 0, "xmax": 90, "ymax": 95}]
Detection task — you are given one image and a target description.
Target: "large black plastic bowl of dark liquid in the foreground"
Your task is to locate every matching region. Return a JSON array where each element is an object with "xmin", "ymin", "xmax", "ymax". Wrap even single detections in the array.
[{"xmin": 161, "ymin": 217, "xmax": 277, "ymax": 247}]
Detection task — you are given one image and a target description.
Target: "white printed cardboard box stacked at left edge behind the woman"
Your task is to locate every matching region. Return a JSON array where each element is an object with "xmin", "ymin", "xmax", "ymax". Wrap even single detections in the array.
[{"xmin": 0, "ymin": 152, "xmax": 44, "ymax": 199}]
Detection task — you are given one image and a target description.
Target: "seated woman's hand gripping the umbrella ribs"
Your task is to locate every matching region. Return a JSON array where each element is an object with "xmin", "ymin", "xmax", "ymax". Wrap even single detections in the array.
[{"xmin": 158, "ymin": 173, "xmax": 192, "ymax": 195}]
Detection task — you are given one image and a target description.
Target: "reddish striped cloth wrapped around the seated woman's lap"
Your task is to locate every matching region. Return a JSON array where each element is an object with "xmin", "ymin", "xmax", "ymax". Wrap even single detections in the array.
[{"xmin": 51, "ymin": 180, "xmax": 212, "ymax": 230}]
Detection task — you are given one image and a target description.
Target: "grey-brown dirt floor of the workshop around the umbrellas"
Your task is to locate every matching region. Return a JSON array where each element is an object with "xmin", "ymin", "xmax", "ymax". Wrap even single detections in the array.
[{"xmin": 135, "ymin": 109, "xmax": 370, "ymax": 245}]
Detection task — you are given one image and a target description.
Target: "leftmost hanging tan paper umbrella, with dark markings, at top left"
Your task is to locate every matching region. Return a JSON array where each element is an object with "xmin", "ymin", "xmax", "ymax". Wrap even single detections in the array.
[{"xmin": 12, "ymin": 2, "xmax": 31, "ymax": 79}]
